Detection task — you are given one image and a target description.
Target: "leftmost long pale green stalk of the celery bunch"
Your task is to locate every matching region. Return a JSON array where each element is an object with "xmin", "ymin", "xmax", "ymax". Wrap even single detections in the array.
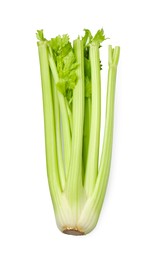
[{"xmin": 38, "ymin": 42, "xmax": 61, "ymax": 205}]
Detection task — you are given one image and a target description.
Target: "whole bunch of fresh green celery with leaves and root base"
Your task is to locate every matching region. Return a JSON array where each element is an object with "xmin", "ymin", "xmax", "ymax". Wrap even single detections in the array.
[{"xmin": 36, "ymin": 29, "xmax": 120, "ymax": 235}]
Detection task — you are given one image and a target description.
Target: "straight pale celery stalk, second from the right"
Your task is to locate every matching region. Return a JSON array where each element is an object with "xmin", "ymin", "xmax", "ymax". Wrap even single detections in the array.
[{"xmin": 85, "ymin": 44, "xmax": 101, "ymax": 196}]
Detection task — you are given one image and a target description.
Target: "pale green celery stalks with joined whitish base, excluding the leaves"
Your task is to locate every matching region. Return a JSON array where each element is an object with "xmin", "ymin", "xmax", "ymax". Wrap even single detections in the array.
[{"xmin": 38, "ymin": 39, "xmax": 120, "ymax": 235}]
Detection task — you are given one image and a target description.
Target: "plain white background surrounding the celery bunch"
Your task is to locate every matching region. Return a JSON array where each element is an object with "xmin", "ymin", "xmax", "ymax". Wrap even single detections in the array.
[{"xmin": 0, "ymin": 0, "xmax": 157, "ymax": 260}]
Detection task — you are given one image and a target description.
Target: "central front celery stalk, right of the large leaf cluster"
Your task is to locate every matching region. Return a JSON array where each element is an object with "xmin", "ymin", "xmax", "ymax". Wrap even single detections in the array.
[{"xmin": 67, "ymin": 39, "xmax": 84, "ymax": 211}]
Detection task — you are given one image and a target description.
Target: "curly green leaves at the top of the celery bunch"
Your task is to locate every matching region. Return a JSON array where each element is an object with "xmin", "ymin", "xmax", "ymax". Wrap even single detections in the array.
[{"xmin": 36, "ymin": 29, "xmax": 106, "ymax": 100}]
